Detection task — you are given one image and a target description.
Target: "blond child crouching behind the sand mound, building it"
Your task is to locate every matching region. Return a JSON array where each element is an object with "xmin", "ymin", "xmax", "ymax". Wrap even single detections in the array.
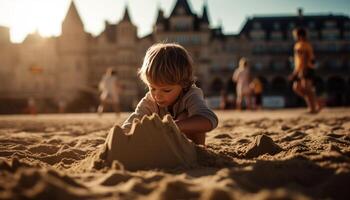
[{"xmin": 122, "ymin": 43, "xmax": 218, "ymax": 145}]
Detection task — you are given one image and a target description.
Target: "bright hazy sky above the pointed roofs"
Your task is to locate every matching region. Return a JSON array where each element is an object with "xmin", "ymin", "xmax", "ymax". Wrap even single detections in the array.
[{"xmin": 0, "ymin": 0, "xmax": 350, "ymax": 42}]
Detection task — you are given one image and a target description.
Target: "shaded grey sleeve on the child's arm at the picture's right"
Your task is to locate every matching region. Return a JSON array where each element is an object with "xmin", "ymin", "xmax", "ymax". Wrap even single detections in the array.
[{"xmin": 185, "ymin": 88, "xmax": 218, "ymax": 129}]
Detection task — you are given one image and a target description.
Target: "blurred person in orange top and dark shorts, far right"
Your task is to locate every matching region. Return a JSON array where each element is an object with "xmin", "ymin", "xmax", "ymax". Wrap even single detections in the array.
[{"xmin": 290, "ymin": 28, "xmax": 321, "ymax": 113}]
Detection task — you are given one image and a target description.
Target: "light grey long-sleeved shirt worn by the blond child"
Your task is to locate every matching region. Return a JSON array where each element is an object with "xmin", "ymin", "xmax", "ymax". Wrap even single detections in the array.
[{"xmin": 122, "ymin": 84, "xmax": 218, "ymax": 131}]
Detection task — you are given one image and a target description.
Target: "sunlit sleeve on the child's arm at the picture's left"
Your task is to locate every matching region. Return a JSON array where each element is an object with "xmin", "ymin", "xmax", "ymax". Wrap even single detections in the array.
[{"xmin": 122, "ymin": 93, "xmax": 156, "ymax": 132}]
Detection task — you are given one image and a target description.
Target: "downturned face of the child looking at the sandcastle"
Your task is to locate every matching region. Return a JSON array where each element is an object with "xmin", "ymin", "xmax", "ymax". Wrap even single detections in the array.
[{"xmin": 148, "ymin": 83, "xmax": 182, "ymax": 107}]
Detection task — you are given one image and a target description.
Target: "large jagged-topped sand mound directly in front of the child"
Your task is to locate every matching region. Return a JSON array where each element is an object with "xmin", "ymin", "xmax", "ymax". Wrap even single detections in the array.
[{"xmin": 100, "ymin": 114, "xmax": 197, "ymax": 170}]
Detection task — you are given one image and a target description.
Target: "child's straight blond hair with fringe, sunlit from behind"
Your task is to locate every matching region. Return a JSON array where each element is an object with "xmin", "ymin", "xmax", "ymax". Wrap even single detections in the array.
[{"xmin": 138, "ymin": 43, "xmax": 194, "ymax": 88}]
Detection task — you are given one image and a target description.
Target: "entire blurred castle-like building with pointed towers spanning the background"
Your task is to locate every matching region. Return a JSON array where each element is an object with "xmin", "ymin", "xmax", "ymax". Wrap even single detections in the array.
[{"xmin": 0, "ymin": 0, "xmax": 350, "ymax": 113}]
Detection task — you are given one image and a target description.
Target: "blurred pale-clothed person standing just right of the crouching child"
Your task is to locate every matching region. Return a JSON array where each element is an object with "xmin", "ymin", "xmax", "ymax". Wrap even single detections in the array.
[{"xmin": 232, "ymin": 57, "xmax": 251, "ymax": 110}]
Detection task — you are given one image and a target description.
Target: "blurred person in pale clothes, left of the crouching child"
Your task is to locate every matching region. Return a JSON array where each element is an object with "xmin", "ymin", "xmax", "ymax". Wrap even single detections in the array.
[{"xmin": 97, "ymin": 68, "xmax": 121, "ymax": 115}]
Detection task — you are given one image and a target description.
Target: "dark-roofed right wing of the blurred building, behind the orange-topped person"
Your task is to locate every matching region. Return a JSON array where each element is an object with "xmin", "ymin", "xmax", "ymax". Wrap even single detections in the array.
[{"xmin": 239, "ymin": 9, "xmax": 350, "ymax": 106}]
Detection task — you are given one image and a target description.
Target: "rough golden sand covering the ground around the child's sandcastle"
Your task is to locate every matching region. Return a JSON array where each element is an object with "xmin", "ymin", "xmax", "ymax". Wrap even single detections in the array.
[{"xmin": 0, "ymin": 108, "xmax": 350, "ymax": 199}]
